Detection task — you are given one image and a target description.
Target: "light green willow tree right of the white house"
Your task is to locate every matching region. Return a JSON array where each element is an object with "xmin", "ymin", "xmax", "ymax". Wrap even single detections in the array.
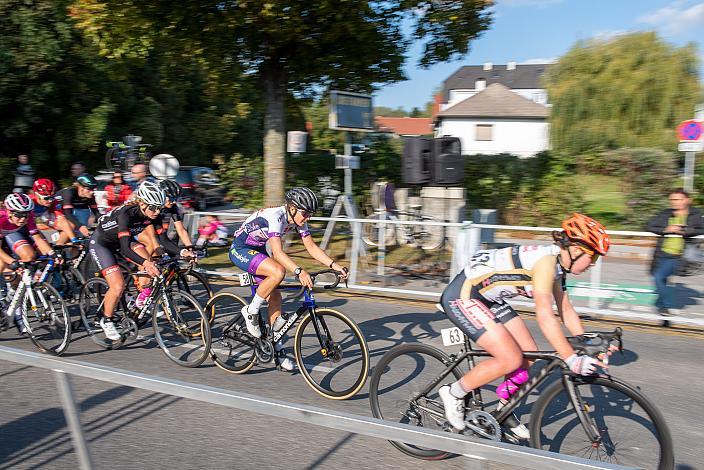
[{"xmin": 545, "ymin": 32, "xmax": 699, "ymax": 153}]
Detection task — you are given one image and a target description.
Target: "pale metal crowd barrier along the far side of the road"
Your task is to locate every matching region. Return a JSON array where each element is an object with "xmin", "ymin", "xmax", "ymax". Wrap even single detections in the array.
[{"xmin": 184, "ymin": 212, "xmax": 704, "ymax": 327}]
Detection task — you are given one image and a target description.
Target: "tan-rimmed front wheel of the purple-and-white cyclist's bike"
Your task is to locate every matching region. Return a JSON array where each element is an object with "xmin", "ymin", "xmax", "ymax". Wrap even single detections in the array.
[{"xmin": 294, "ymin": 308, "xmax": 369, "ymax": 400}]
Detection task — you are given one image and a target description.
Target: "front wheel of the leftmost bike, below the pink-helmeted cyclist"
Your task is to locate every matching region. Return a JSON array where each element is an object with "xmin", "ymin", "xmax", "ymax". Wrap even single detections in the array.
[{"xmin": 22, "ymin": 283, "xmax": 71, "ymax": 356}]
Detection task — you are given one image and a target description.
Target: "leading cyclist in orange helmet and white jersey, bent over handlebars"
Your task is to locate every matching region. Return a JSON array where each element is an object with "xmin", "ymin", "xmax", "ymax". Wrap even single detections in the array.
[{"xmin": 438, "ymin": 213, "xmax": 610, "ymax": 439}]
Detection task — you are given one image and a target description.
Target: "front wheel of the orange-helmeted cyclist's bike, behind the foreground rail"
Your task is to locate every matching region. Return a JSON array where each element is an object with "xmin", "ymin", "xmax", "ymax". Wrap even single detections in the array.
[{"xmin": 530, "ymin": 377, "xmax": 674, "ymax": 470}]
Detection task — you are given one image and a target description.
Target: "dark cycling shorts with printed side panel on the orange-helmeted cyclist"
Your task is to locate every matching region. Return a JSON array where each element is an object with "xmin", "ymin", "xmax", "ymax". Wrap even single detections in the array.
[{"xmin": 440, "ymin": 271, "xmax": 518, "ymax": 341}]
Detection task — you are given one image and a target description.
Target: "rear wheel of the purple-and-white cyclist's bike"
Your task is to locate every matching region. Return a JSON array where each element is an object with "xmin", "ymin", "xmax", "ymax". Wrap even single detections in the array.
[{"xmin": 205, "ymin": 292, "xmax": 256, "ymax": 374}]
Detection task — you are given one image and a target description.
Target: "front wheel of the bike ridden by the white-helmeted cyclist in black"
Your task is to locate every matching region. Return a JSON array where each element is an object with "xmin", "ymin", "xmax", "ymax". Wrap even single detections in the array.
[{"xmin": 152, "ymin": 290, "xmax": 210, "ymax": 367}]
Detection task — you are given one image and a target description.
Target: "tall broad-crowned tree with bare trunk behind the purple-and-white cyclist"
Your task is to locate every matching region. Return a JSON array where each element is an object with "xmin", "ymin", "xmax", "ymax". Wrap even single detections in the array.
[{"xmin": 72, "ymin": 0, "xmax": 492, "ymax": 204}]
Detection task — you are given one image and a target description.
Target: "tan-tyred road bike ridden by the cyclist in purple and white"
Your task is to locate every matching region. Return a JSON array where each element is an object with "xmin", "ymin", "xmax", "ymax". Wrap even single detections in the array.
[{"xmin": 206, "ymin": 269, "xmax": 369, "ymax": 400}]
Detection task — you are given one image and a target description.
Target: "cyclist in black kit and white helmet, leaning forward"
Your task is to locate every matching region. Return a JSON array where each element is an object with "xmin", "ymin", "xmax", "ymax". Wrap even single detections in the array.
[{"xmin": 89, "ymin": 181, "xmax": 171, "ymax": 341}]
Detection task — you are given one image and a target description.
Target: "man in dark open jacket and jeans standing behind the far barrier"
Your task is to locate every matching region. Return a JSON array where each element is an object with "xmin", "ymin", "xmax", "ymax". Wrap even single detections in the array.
[{"xmin": 646, "ymin": 189, "xmax": 704, "ymax": 315}]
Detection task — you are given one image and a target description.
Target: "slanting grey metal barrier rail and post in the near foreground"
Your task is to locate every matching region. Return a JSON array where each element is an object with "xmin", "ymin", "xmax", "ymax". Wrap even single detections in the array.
[{"xmin": 0, "ymin": 346, "xmax": 628, "ymax": 470}]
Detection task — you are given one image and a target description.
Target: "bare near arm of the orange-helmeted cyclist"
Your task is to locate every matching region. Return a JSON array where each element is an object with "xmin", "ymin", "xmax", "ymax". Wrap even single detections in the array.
[{"xmin": 533, "ymin": 256, "xmax": 574, "ymax": 359}]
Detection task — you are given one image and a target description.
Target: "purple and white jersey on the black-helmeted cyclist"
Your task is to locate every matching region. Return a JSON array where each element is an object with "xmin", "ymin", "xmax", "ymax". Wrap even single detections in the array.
[{"xmin": 232, "ymin": 205, "xmax": 310, "ymax": 248}]
